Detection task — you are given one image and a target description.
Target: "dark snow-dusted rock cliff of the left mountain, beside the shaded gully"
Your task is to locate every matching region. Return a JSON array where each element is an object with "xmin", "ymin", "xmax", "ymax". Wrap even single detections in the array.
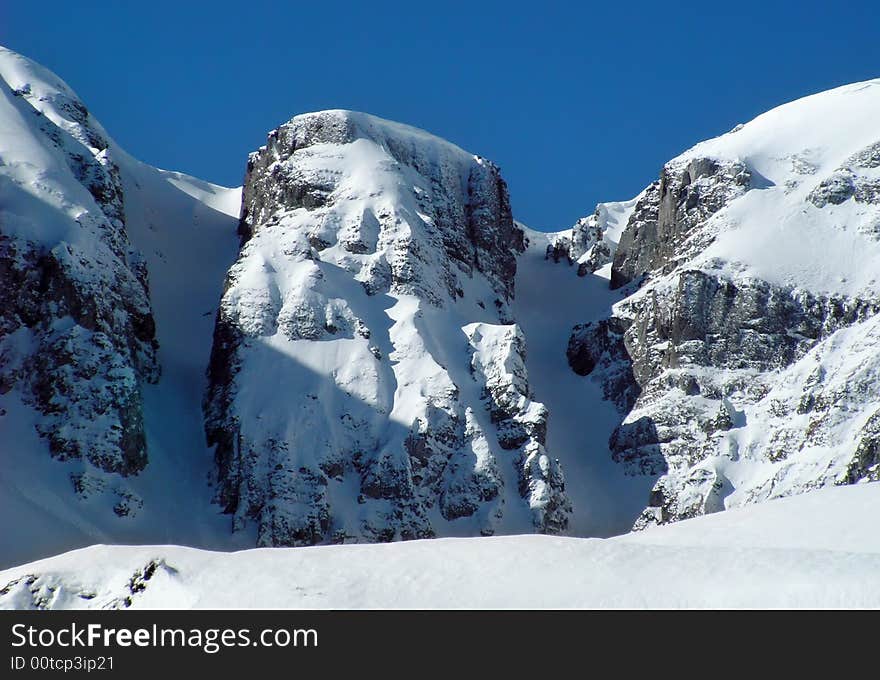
[{"xmin": 0, "ymin": 50, "xmax": 159, "ymax": 504}]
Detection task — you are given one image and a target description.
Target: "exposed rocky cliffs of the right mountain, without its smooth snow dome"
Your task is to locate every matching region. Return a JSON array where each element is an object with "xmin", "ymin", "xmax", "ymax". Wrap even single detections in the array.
[{"xmin": 568, "ymin": 145, "xmax": 880, "ymax": 529}]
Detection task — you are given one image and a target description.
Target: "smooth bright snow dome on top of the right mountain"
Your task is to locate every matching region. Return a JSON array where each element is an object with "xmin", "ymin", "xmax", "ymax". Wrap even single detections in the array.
[{"xmin": 684, "ymin": 79, "xmax": 880, "ymax": 297}]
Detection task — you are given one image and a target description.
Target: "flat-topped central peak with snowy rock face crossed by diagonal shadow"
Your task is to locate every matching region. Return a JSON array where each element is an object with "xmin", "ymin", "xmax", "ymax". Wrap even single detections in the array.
[{"xmin": 206, "ymin": 111, "xmax": 569, "ymax": 545}]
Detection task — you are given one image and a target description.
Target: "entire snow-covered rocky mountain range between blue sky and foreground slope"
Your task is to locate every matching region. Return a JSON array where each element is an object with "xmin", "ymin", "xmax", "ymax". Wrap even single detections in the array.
[{"xmin": 0, "ymin": 42, "xmax": 880, "ymax": 587}]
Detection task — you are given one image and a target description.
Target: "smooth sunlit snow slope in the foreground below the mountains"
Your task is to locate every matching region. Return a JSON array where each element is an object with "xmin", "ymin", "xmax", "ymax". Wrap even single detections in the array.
[{"xmin": 0, "ymin": 484, "xmax": 880, "ymax": 609}]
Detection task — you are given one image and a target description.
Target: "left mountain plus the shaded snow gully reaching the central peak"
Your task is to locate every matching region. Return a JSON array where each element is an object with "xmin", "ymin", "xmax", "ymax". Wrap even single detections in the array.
[{"xmin": 0, "ymin": 49, "xmax": 246, "ymax": 565}]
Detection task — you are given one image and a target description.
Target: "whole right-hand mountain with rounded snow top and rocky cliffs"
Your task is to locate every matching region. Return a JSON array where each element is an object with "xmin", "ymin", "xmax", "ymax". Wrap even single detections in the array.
[{"xmin": 569, "ymin": 81, "xmax": 880, "ymax": 527}]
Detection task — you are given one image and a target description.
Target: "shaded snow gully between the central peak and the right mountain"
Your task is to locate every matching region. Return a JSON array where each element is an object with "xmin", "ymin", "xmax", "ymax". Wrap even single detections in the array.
[{"xmin": 513, "ymin": 224, "xmax": 653, "ymax": 536}]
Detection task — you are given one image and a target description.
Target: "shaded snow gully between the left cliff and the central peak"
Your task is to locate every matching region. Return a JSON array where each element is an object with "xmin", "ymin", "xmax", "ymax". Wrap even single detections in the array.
[{"xmin": 94, "ymin": 161, "xmax": 252, "ymax": 549}]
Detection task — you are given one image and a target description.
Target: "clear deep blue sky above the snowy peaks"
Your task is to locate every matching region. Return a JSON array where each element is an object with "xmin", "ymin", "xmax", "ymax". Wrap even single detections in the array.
[{"xmin": 0, "ymin": 0, "xmax": 880, "ymax": 229}]
